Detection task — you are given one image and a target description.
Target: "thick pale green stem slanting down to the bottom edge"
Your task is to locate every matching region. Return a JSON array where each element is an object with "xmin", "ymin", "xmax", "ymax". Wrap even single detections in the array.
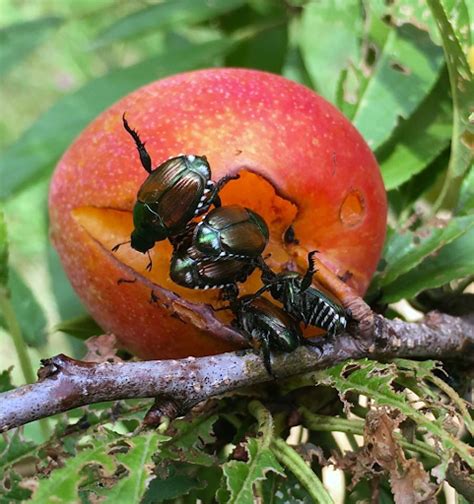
[{"xmin": 271, "ymin": 438, "xmax": 334, "ymax": 504}]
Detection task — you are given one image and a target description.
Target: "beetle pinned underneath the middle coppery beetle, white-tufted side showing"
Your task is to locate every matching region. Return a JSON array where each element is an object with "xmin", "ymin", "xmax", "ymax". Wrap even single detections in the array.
[{"xmin": 170, "ymin": 230, "xmax": 257, "ymax": 292}]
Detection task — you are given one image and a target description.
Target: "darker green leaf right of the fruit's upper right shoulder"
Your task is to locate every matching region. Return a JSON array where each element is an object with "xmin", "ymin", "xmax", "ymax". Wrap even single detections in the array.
[{"xmin": 377, "ymin": 70, "xmax": 452, "ymax": 191}]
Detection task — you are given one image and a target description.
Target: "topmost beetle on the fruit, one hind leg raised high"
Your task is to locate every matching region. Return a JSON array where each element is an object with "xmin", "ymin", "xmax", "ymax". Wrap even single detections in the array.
[{"xmin": 112, "ymin": 114, "xmax": 238, "ymax": 260}]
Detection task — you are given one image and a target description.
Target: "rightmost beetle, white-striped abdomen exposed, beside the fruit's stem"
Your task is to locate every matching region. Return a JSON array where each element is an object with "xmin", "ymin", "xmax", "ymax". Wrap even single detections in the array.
[{"xmin": 254, "ymin": 250, "xmax": 349, "ymax": 336}]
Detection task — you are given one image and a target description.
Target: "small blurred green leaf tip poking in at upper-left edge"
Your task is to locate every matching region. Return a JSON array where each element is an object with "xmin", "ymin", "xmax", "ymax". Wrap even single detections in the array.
[{"xmin": 0, "ymin": 17, "xmax": 62, "ymax": 76}]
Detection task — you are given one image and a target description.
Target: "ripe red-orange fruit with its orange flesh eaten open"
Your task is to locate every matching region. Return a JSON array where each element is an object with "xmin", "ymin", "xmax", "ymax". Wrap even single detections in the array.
[{"xmin": 50, "ymin": 69, "xmax": 387, "ymax": 358}]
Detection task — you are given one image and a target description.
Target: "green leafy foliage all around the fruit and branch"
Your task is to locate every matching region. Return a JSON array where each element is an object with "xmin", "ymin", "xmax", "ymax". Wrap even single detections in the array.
[{"xmin": 0, "ymin": 0, "xmax": 474, "ymax": 502}]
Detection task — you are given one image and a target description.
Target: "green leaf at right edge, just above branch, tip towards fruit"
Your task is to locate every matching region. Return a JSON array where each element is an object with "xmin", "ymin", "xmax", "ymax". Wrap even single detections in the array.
[{"xmin": 381, "ymin": 227, "xmax": 474, "ymax": 303}]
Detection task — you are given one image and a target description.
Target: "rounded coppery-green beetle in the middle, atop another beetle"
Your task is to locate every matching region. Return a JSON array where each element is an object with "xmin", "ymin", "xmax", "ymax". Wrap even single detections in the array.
[{"xmin": 193, "ymin": 205, "xmax": 269, "ymax": 258}]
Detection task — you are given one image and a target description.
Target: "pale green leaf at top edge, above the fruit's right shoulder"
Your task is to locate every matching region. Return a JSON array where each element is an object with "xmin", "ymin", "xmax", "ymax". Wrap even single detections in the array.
[{"xmin": 299, "ymin": 0, "xmax": 362, "ymax": 103}]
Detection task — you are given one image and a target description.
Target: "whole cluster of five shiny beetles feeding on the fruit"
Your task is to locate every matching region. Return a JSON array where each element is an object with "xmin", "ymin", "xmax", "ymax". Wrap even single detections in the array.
[{"xmin": 113, "ymin": 114, "xmax": 349, "ymax": 375}]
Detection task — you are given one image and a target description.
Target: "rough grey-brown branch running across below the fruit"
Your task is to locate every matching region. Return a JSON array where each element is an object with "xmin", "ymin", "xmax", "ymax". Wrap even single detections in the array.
[{"xmin": 0, "ymin": 312, "xmax": 474, "ymax": 431}]
